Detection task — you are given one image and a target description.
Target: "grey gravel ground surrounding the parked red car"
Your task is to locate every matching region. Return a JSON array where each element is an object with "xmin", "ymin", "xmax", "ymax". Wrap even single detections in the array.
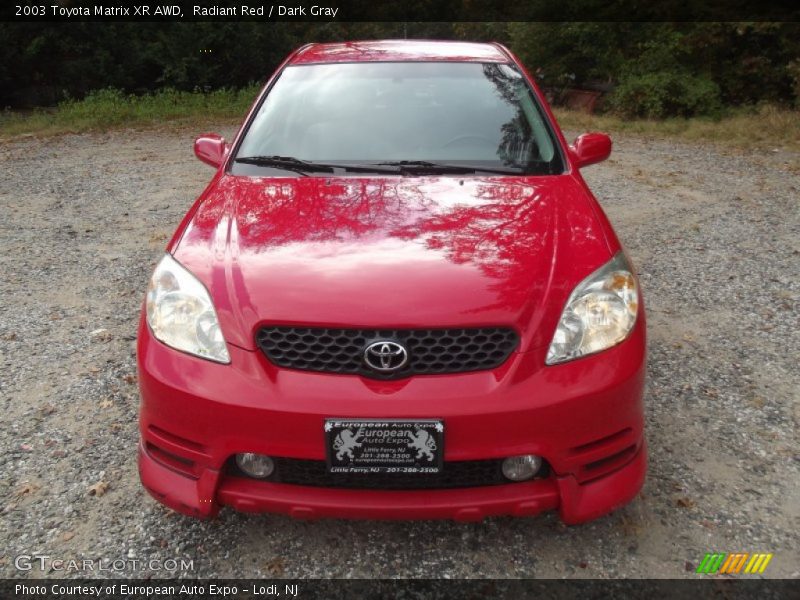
[{"xmin": 0, "ymin": 131, "xmax": 800, "ymax": 578}]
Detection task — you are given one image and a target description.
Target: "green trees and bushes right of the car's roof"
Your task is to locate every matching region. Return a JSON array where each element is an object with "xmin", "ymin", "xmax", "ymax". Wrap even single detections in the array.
[{"xmin": 509, "ymin": 22, "xmax": 800, "ymax": 117}]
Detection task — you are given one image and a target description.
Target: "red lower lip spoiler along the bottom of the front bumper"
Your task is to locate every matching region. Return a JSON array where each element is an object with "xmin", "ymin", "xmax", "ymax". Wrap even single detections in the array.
[{"xmin": 139, "ymin": 444, "xmax": 647, "ymax": 524}]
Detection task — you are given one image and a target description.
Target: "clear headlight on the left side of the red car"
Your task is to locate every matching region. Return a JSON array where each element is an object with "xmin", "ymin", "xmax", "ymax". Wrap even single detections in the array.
[{"xmin": 146, "ymin": 254, "xmax": 231, "ymax": 363}]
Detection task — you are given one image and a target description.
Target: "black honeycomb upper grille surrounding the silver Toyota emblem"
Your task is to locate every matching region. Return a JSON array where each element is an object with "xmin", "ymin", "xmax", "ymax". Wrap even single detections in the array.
[{"xmin": 256, "ymin": 326, "xmax": 519, "ymax": 379}]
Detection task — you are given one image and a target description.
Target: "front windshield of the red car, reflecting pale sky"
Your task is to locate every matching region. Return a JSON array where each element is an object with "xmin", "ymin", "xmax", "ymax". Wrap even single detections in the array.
[{"xmin": 233, "ymin": 62, "xmax": 563, "ymax": 175}]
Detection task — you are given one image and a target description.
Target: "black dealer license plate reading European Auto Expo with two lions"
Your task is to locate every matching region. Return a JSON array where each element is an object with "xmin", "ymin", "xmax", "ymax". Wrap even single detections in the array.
[{"xmin": 325, "ymin": 419, "xmax": 444, "ymax": 474}]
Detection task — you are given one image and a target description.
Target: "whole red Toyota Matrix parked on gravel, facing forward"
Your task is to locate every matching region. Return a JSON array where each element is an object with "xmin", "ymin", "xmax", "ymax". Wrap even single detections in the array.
[{"xmin": 138, "ymin": 41, "xmax": 647, "ymax": 523}]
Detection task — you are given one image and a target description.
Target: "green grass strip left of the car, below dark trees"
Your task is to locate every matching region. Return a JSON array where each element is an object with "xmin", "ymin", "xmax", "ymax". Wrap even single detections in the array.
[{"xmin": 0, "ymin": 85, "xmax": 259, "ymax": 137}]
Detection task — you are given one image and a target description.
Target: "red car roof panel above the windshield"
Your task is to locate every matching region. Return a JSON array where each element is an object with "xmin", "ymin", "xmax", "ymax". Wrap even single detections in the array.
[{"xmin": 290, "ymin": 40, "xmax": 511, "ymax": 65}]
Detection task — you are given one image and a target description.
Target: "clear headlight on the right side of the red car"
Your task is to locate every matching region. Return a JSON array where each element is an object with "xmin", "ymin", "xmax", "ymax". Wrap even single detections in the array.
[{"xmin": 545, "ymin": 252, "xmax": 639, "ymax": 365}]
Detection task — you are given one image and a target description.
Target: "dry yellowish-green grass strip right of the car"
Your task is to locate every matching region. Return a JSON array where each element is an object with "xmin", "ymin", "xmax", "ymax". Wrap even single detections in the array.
[{"xmin": 555, "ymin": 105, "xmax": 800, "ymax": 150}]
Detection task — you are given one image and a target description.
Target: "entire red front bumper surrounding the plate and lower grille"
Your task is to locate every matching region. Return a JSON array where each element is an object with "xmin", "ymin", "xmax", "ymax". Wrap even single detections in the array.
[{"xmin": 138, "ymin": 321, "xmax": 647, "ymax": 524}]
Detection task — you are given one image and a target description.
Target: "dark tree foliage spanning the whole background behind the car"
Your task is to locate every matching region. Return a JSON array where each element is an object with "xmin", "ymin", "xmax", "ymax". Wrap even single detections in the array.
[{"xmin": 0, "ymin": 20, "xmax": 800, "ymax": 117}]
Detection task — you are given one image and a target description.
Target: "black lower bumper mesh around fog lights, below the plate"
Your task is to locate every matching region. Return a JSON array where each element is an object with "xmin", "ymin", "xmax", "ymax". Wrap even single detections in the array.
[{"xmin": 228, "ymin": 458, "xmax": 549, "ymax": 490}]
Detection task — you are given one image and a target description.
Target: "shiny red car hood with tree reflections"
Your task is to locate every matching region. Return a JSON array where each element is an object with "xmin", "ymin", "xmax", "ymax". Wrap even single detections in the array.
[{"xmin": 172, "ymin": 175, "xmax": 610, "ymax": 350}]
